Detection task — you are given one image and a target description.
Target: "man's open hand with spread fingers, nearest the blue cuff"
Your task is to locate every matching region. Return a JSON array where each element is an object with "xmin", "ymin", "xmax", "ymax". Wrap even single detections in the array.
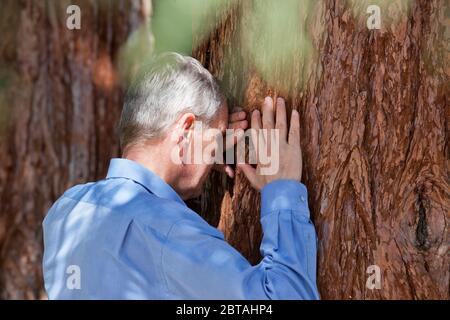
[{"xmin": 238, "ymin": 97, "xmax": 302, "ymax": 190}]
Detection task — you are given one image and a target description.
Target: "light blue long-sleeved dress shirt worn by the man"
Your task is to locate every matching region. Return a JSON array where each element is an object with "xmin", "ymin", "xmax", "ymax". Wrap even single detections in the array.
[{"xmin": 43, "ymin": 159, "xmax": 319, "ymax": 299}]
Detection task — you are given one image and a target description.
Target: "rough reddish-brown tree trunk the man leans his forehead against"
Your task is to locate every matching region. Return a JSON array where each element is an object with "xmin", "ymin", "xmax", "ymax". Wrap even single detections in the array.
[{"xmin": 193, "ymin": 0, "xmax": 450, "ymax": 299}]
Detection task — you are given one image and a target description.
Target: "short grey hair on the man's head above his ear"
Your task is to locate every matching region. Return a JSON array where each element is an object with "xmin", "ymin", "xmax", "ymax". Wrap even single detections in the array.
[{"xmin": 119, "ymin": 52, "xmax": 225, "ymax": 149}]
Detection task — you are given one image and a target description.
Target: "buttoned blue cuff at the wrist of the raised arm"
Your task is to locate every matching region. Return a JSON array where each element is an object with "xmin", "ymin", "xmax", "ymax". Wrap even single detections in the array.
[{"xmin": 261, "ymin": 180, "xmax": 309, "ymax": 219}]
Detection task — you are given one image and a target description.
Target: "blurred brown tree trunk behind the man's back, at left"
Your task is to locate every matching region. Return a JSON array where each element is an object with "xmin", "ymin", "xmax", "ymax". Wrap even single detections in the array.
[{"xmin": 0, "ymin": 0, "xmax": 148, "ymax": 298}]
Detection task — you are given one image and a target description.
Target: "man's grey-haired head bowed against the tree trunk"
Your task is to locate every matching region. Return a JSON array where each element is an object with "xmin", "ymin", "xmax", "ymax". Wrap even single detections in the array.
[{"xmin": 119, "ymin": 53, "xmax": 228, "ymax": 199}]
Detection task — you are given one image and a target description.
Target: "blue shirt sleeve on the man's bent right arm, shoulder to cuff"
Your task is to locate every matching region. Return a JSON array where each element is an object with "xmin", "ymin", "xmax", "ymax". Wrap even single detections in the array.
[{"xmin": 161, "ymin": 180, "xmax": 319, "ymax": 300}]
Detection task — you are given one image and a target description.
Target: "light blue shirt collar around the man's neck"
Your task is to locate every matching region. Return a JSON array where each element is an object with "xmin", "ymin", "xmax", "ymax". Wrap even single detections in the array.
[{"xmin": 106, "ymin": 158, "xmax": 186, "ymax": 205}]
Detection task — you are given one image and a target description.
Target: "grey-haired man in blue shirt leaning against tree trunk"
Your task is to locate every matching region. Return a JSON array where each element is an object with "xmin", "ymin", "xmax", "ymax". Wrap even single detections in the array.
[{"xmin": 43, "ymin": 53, "xmax": 319, "ymax": 299}]
